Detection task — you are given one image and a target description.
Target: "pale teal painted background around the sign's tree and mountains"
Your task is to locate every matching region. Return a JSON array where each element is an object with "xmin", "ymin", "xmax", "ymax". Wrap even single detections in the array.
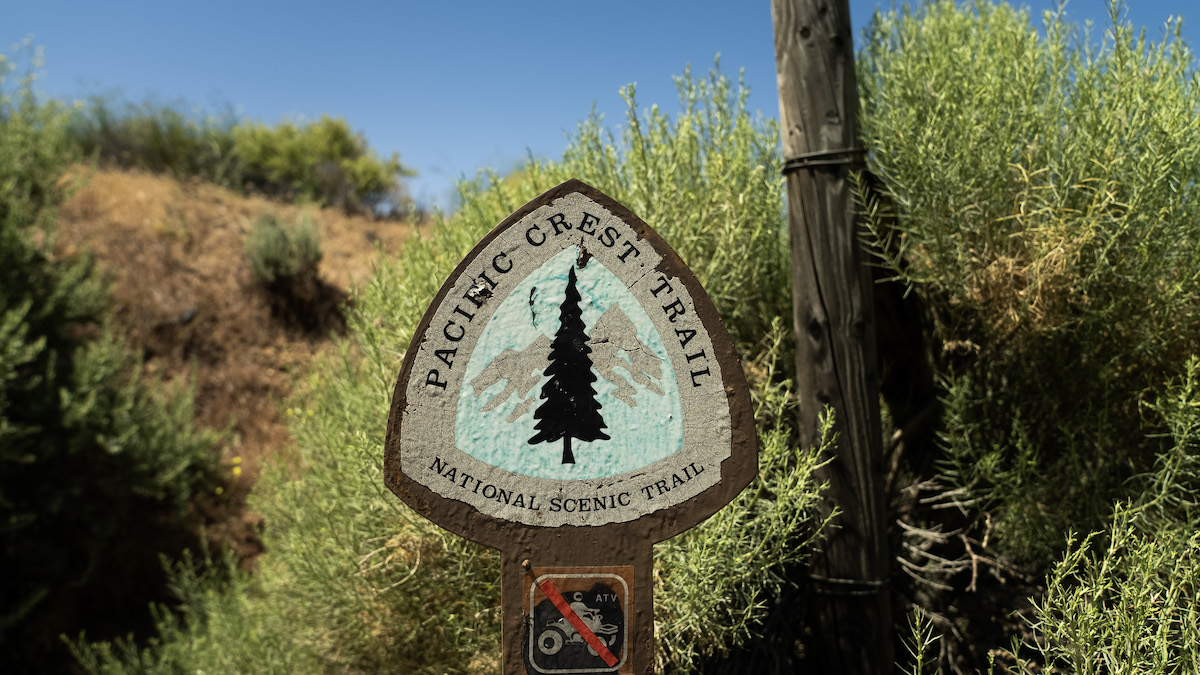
[{"xmin": 455, "ymin": 246, "xmax": 683, "ymax": 480}]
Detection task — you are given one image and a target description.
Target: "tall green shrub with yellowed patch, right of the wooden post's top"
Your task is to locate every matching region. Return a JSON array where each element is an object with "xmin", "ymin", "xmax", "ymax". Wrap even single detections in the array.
[{"xmin": 859, "ymin": 1, "xmax": 1200, "ymax": 563}]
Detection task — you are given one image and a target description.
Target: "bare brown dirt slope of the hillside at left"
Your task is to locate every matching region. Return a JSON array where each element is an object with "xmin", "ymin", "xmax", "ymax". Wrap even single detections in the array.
[{"xmin": 55, "ymin": 171, "xmax": 409, "ymax": 560}]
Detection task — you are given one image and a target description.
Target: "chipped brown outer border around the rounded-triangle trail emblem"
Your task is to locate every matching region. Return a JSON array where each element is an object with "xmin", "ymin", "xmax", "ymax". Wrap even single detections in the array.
[{"xmin": 384, "ymin": 179, "xmax": 758, "ymax": 549}]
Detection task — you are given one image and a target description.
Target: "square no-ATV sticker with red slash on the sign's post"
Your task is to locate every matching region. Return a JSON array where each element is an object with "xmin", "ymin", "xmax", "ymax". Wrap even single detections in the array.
[{"xmin": 524, "ymin": 567, "xmax": 632, "ymax": 675}]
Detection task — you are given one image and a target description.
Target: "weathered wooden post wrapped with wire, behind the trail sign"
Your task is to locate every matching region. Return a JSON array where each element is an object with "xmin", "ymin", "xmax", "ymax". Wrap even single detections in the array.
[{"xmin": 772, "ymin": 0, "xmax": 894, "ymax": 674}]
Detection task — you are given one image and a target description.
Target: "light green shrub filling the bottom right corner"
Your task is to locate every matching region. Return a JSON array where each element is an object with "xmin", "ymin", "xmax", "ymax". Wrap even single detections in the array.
[{"xmin": 1014, "ymin": 359, "xmax": 1200, "ymax": 674}]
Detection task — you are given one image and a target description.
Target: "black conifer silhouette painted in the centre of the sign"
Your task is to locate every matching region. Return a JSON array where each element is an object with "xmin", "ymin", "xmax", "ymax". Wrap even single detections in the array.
[{"xmin": 529, "ymin": 264, "xmax": 608, "ymax": 464}]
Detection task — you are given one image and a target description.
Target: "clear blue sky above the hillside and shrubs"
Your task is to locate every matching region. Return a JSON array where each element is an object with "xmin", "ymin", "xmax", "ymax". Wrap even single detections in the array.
[{"xmin": 0, "ymin": 0, "xmax": 1200, "ymax": 207}]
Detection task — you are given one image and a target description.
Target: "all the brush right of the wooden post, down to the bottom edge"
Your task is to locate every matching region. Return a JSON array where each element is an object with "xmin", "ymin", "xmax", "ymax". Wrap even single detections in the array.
[{"xmin": 859, "ymin": 2, "xmax": 1200, "ymax": 673}]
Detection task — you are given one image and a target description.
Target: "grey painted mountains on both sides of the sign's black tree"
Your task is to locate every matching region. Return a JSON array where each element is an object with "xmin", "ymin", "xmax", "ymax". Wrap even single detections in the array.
[{"xmin": 470, "ymin": 304, "xmax": 664, "ymax": 424}]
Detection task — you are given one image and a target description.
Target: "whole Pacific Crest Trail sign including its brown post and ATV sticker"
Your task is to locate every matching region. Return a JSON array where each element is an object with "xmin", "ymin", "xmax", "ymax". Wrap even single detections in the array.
[{"xmin": 384, "ymin": 180, "xmax": 757, "ymax": 675}]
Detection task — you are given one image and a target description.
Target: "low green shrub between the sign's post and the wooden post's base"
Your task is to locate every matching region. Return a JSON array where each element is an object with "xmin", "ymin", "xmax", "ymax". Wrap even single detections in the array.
[{"xmin": 654, "ymin": 333, "xmax": 835, "ymax": 673}]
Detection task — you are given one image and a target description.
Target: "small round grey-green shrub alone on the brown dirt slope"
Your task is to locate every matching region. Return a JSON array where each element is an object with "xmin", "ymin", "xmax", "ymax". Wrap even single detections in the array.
[{"xmin": 246, "ymin": 215, "xmax": 323, "ymax": 285}]
